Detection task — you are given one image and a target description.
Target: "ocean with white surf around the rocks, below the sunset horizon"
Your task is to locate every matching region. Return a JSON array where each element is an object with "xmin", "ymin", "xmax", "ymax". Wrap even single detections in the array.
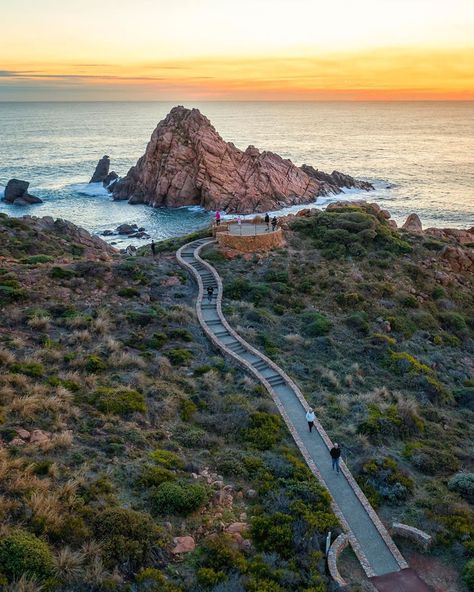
[{"xmin": 0, "ymin": 102, "xmax": 474, "ymax": 246}]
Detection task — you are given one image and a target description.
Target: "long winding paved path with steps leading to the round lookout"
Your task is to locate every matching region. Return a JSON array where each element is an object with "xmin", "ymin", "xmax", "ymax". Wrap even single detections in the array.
[{"xmin": 177, "ymin": 239, "xmax": 409, "ymax": 580}]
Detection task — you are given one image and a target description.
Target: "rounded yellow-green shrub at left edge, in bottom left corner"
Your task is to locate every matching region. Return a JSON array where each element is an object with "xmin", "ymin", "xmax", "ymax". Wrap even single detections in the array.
[{"xmin": 0, "ymin": 530, "xmax": 53, "ymax": 582}]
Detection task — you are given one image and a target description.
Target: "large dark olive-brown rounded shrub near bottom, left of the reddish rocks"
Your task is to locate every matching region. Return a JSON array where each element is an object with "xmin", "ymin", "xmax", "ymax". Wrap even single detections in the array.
[{"xmin": 93, "ymin": 508, "xmax": 167, "ymax": 570}]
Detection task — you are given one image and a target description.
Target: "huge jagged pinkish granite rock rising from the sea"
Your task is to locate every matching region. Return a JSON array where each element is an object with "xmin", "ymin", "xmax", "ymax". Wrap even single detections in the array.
[{"xmin": 111, "ymin": 107, "xmax": 373, "ymax": 213}]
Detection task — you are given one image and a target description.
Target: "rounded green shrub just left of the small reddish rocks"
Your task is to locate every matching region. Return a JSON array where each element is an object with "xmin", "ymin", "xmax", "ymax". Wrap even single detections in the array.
[{"xmin": 150, "ymin": 482, "xmax": 209, "ymax": 516}]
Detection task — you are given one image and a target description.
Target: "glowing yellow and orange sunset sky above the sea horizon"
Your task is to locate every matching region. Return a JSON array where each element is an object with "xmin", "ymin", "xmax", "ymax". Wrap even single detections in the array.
[{"xmin": 0, "ymin": 0, "xmax": 474, "ymax": 101}]
